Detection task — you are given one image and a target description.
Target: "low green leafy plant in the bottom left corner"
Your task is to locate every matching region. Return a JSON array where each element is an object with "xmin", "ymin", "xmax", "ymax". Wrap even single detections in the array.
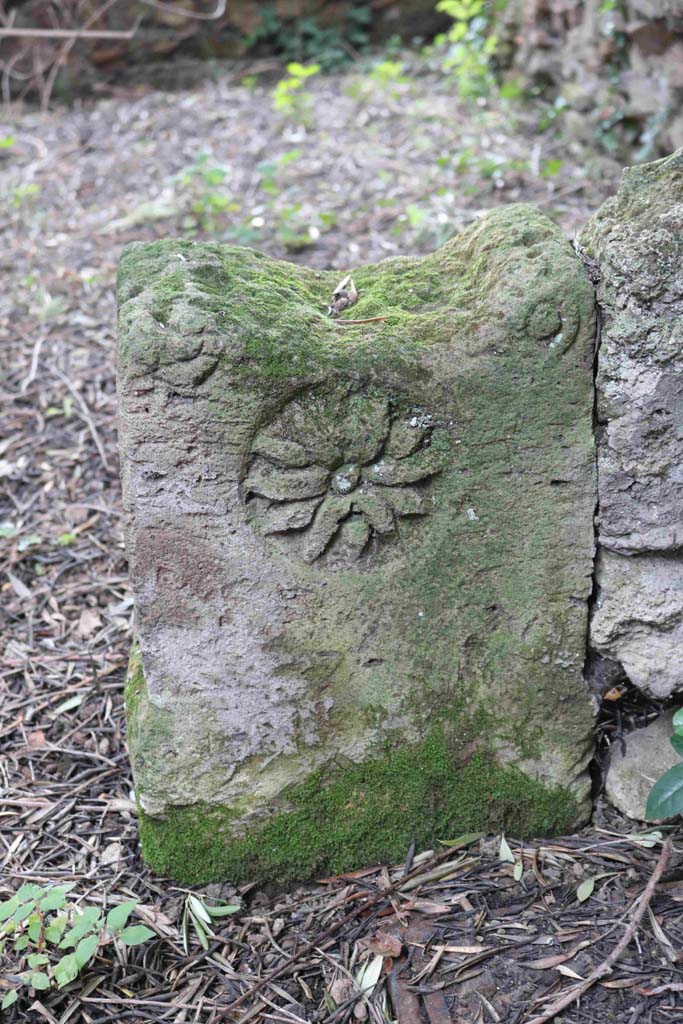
[{"xmin": 0, "ymin": 884, "xmax": 155, "ymax": 1010}]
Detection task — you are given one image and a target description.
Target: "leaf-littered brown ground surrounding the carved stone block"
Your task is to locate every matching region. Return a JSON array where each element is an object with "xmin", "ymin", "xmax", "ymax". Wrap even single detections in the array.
[{"xmin": 0, "ymin": 58, "xmax": 683, "ymax": 1024}]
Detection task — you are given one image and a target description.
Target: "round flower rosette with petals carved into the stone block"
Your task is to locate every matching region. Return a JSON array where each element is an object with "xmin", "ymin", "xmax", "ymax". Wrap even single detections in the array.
[{"xmin": 242, "ymin": 391, "xmax": 449, "ymax": 564}]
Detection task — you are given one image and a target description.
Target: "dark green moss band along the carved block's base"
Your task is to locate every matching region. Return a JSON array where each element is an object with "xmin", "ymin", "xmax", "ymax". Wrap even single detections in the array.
[{"xmin": 140, "ymin": 729, "xmax": 577, "ymax": 885}]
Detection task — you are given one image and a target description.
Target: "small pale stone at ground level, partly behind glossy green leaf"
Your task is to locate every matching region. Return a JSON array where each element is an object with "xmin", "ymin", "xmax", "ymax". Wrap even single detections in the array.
[{"xmin": 605, "ymin": 709, "xmax": 681, "ymax": 821}]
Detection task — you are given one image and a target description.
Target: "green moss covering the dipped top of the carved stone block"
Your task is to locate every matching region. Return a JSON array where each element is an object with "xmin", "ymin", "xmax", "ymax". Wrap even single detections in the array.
[{"xmin": 118, "ymin": 204, "xmax": 590, "ymax": 385}]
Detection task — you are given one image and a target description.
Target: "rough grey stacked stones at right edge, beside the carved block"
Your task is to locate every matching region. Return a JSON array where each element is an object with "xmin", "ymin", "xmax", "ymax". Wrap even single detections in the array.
[{"xmin": 581, "ymin": 151, "xmax": 683, "ymax": 696}]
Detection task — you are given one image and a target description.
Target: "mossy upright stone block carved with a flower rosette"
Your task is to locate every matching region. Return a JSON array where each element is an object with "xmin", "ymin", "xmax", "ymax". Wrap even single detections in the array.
[{"xmin": 119, "ymin": 207, "xmax": 596, "ymax": 881}]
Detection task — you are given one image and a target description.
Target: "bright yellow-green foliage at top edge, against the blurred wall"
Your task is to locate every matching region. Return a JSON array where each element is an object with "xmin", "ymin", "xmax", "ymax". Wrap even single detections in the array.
[{"xmin": 434, "ymin": 0, "xmax": 499, "ymax": 99}]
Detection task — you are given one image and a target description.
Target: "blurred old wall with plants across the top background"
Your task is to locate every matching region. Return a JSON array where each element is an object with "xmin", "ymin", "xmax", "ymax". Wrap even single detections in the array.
[{"xmin": 0, "ymin": 0, "xmax": 683, "ymax": 162}]
